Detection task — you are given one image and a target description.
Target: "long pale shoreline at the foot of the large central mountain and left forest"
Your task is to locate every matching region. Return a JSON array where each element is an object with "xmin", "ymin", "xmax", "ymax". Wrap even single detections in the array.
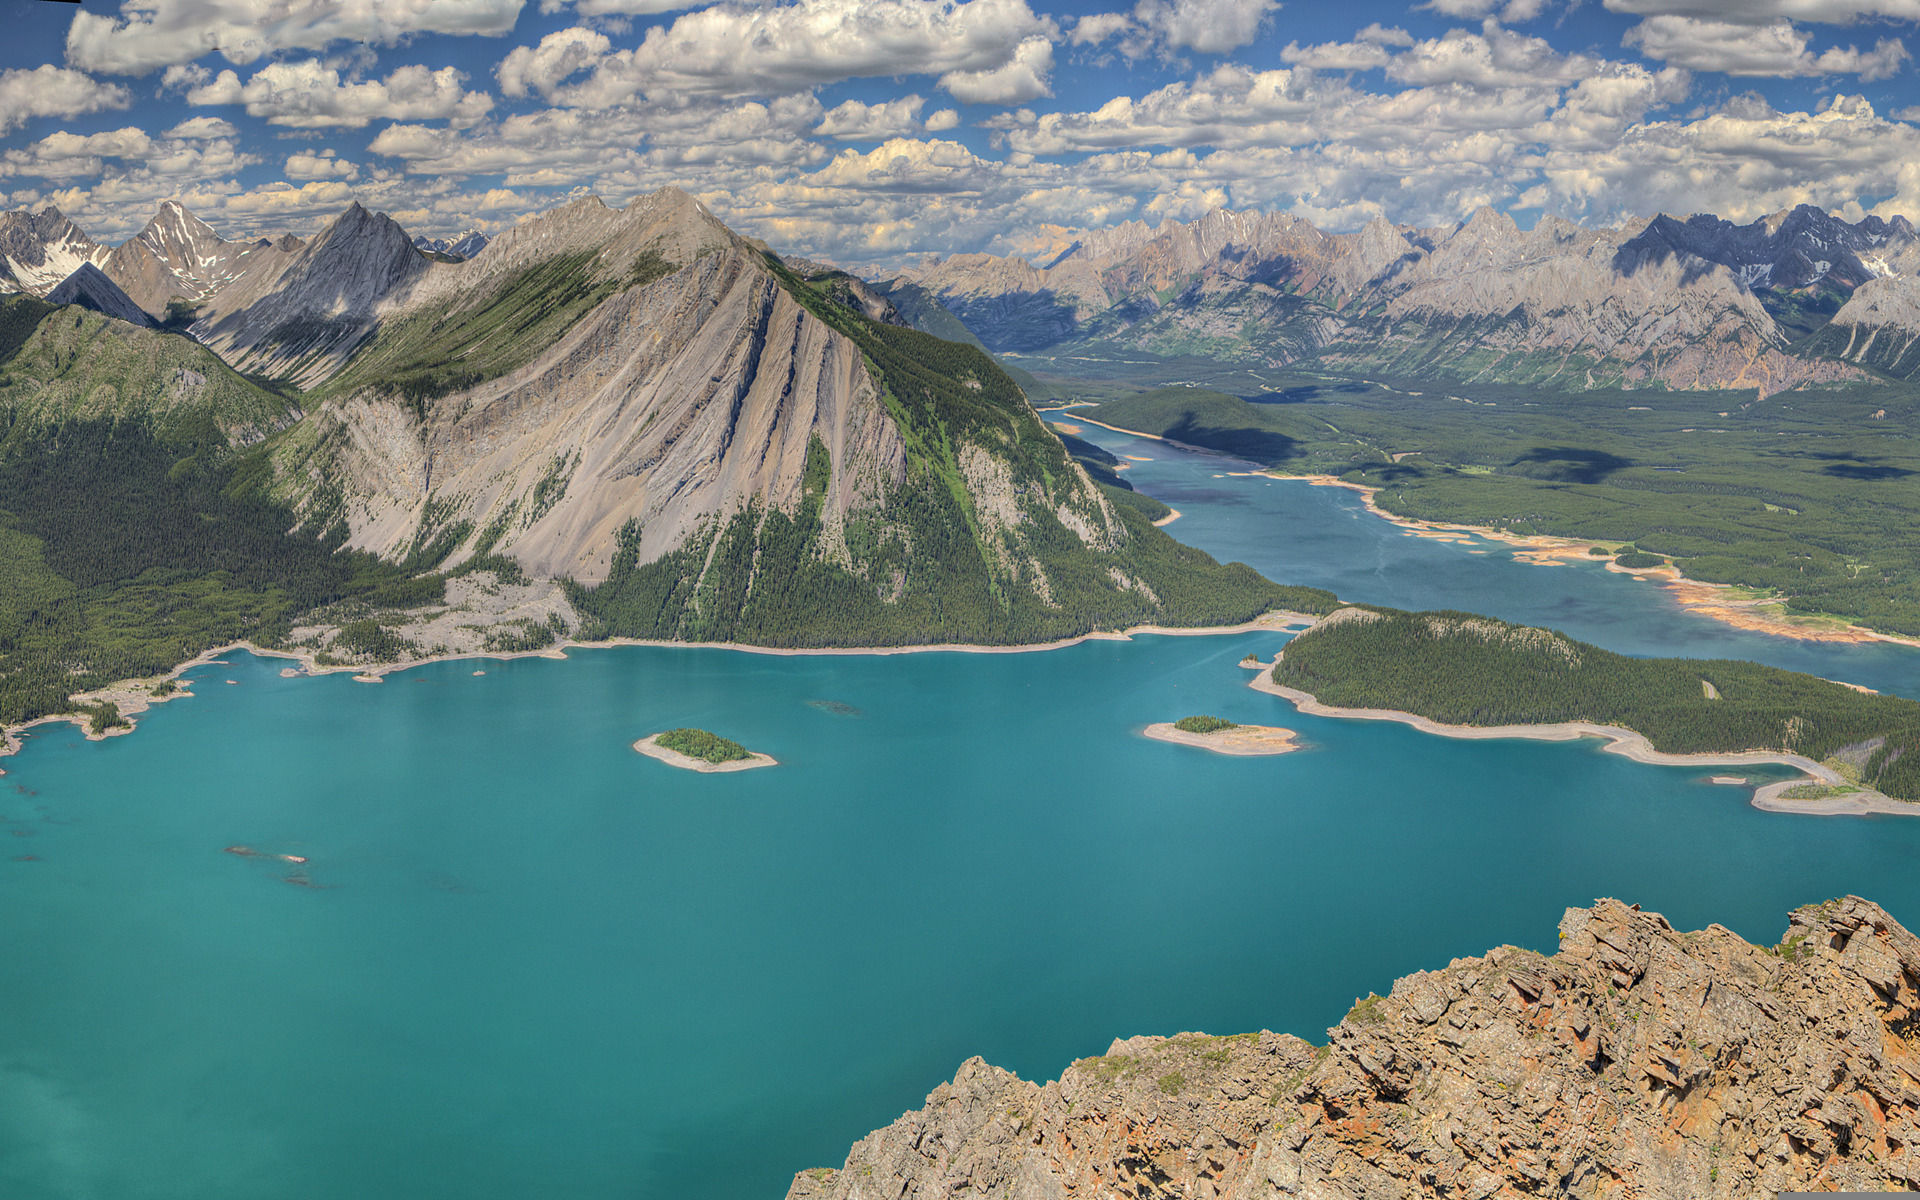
[{"xmin": 0, "ymin": 611, "xmax": 1319, "ymax": 756}]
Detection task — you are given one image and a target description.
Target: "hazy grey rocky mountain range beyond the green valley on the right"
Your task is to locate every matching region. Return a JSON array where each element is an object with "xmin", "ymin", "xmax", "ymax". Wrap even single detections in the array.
[{"xmin": 885, "ymin": 205, "xmax": 1920, "ymax": 392}]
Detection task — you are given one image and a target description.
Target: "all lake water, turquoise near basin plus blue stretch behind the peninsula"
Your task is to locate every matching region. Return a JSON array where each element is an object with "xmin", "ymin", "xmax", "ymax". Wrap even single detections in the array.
[{"xmin": 0, "ymin": 432, "xmax": 1920, "ymax": 1200}]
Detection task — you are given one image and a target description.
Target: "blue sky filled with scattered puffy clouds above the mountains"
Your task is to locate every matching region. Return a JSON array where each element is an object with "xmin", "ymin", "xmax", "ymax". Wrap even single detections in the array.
[{"xmin": 0, "ymin": 0, "xmax": 1920, "ymax": 273}]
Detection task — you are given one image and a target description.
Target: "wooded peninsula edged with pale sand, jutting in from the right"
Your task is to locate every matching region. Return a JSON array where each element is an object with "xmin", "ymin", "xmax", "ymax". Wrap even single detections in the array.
[{"xmin": 1254, "ymin": 607, "xmax": 1920, "ymax": 816}]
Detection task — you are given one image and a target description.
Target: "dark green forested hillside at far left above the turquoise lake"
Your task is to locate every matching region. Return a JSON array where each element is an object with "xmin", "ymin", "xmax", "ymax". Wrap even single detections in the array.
[{"xmin": 0, "ymin": 296, "xmax": 442, "ymax": 724}]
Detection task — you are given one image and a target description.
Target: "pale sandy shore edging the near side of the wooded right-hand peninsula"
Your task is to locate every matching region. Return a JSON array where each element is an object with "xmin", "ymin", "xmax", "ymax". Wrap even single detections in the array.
[{"xmin": 1248, "ymin": 664, "xmax": 1920, "ymax": 816}]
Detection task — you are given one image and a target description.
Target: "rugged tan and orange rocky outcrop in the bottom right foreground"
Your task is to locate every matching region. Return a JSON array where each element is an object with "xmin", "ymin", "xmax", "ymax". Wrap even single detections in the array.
[{"xmin": 787, "ymin": 897, "xmax": 1920, "ymax": 1200}]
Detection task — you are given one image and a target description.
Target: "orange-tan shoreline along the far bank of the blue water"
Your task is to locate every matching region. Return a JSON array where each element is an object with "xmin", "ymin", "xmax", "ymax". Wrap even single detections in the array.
[{"xmin": 1073, "ymin": 413, "xmax": 1920, "ymax": 647}]
